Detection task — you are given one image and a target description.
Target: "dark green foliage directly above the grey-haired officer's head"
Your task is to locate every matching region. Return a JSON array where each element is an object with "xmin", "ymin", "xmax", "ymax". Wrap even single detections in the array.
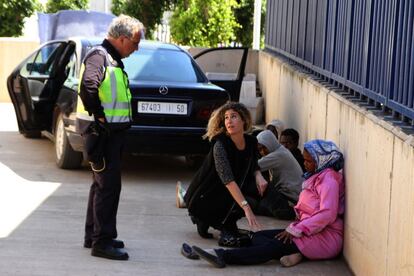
[{"xmin": 112, "ymin": 0, "xmax": 177, "ymax": 37}]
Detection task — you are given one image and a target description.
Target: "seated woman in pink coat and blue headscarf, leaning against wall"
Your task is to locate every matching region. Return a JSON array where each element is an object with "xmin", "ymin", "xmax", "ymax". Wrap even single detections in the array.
[{"xmin": 186, "ymin": 140, "xmax": 344, "ymax": 268}]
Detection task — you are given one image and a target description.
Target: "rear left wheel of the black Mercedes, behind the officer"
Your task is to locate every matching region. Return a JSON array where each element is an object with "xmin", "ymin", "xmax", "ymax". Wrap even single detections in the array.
[{"xmin": 55, "ymin": 114, "xmax": 82, "ymax": 169}]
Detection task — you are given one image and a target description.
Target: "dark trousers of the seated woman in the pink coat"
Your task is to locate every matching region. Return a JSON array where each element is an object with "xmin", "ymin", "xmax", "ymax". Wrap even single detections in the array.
[{"xmin": 216, "ymin": 229, "xmax": 299, "ymax": 265}]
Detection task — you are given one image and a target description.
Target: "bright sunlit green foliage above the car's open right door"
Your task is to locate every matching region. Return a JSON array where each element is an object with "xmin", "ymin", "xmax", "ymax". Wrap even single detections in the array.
[{"xmin": 170, "ymin": 0, "xmax": 240, "ymax": 47}]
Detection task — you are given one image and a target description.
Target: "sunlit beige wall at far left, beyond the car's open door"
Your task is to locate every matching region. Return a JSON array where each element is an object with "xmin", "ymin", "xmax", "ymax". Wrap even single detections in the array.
[{"xmin": 0, "ymin": 37, "xmax": 39, "ymax": 102}]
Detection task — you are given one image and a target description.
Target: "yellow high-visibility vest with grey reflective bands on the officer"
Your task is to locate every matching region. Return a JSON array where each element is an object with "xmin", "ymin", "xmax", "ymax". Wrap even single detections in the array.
[{"xmin": 76, "ymin": 46, "xmax": 132, "ymax": 124}]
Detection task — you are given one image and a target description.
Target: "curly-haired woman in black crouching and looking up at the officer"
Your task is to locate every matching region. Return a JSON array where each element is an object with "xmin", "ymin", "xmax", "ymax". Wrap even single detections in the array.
[{"xmin": 184, "ymin": 102, "xmax": 267, "ymax": 246}]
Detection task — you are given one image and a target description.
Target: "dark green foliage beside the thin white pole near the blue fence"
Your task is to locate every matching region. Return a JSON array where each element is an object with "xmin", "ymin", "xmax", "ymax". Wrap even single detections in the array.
[{"xmin": 234, "ymin": 0, "xmax": 266, "ymax": 47}]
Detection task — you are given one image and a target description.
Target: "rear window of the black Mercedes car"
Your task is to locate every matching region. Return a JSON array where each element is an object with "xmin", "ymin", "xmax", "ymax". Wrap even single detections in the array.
[{"xmin": 123, "ymin": 48, "xmax": 198, "ymax": 82}]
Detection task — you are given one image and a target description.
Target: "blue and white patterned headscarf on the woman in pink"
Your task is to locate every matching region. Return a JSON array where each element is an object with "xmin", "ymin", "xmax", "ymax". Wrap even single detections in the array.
[{"xmin": 303, "ymin": 139, "xmax": 344, "ymax": 179}]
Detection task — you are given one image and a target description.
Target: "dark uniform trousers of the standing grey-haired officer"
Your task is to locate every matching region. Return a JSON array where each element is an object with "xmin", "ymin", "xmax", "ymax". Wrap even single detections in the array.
[{"xmin": 85, "ymin": 131, "xmax": 125, "ymax": 246}]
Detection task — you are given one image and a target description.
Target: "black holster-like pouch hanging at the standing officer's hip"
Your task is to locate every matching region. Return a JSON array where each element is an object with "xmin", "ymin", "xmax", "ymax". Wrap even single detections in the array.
[{"xmin": 85, "ymin": 123, "xmax": 109, "ymax": 172}]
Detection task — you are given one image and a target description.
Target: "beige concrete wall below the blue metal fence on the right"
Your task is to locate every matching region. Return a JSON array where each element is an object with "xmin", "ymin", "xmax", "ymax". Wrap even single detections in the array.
[{"xmin": 258, "ymin": 52, "xmax": 414, "ymax": 276}]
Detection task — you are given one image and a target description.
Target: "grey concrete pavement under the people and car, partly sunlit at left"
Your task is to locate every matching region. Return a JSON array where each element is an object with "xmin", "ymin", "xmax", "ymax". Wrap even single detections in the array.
[{"xmin": 0, "ymin": 104, "xmax": 352, "ymax": 276}]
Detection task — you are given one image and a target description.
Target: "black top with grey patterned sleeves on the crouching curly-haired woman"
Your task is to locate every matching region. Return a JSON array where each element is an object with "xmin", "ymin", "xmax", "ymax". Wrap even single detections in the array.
[{"xmin": 184, "ymin": 134, "xmax": 259, "ymax": 228}]
